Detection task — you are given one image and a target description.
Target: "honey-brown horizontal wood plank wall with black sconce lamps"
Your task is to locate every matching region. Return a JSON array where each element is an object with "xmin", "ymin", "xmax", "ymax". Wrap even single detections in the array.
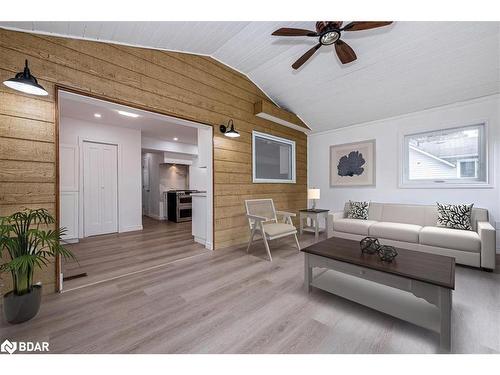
[{"xmin": 0, "ymin": 29, "xmax": 307, "ymax": 294}]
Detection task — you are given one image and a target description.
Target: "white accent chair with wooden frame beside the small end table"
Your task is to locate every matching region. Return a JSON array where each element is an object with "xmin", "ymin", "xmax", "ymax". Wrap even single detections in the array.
[{"xmin": 245, "ymin": 199, "xmax": 300, "ymax": 261}]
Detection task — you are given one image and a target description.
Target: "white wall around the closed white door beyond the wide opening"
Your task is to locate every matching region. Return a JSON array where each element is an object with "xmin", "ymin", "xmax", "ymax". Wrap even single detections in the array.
[{"xmin": 59, "ymin": 117, "xmax": 142, "ymax": 238}]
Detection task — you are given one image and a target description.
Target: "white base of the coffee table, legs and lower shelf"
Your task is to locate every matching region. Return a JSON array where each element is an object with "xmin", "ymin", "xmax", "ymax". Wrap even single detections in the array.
[{"xmin": 305, "ymin": 253, "xmax": 451, "ymax": 351}]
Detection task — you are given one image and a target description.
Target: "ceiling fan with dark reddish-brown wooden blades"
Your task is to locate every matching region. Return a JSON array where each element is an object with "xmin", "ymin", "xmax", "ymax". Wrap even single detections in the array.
[{"xmin": 272, "ymin": 21, "xmax": 392, "ymax": 69}]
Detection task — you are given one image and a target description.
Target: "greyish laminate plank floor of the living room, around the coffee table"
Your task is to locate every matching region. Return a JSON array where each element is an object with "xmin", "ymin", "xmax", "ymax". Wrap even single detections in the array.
[{"xmin": 0, "ymin": 234, "xmax": 500, "ymax": 353}]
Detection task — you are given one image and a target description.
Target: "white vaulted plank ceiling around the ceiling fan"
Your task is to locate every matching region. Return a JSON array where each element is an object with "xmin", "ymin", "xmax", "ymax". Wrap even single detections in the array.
[{"xmin": 0, "ymin": 21, "xmax": 500, "ymax": 132}]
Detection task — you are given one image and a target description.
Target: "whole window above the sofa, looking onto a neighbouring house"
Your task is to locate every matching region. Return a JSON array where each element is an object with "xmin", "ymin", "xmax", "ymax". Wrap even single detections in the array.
[{"xmin": 402, "ymin": 124, "xmax": 488, "ymax": 187}]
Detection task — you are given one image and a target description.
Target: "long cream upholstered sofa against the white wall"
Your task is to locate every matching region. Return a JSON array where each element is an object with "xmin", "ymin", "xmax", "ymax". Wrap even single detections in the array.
[{"xmin": 328, "ymin": 202, "xmax": 496, "ymax": 270}]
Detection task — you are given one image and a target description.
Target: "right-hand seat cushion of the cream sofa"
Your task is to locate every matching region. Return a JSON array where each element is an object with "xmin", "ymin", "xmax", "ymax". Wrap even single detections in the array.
[{"xmin": 420, "ymin": 227, "xmax": 481, "ymax": 252}]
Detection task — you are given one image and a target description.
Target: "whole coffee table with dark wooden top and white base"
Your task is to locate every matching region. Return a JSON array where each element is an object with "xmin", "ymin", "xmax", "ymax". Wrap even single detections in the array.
[{"xmin": 302, "ymin": 237, "xmax": 455, "ymax": 351}]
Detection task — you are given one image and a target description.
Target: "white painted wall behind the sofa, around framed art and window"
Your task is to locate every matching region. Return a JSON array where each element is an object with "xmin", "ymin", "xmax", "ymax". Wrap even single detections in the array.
[{"xmin": 308, "ymin": 94, "xmax": 500, "ymax": 251}]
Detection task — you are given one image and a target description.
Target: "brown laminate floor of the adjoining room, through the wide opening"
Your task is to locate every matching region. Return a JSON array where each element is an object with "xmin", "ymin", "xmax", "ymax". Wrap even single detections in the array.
[{"xmin": 63, "ymin": 216, "xmax": 208, "ymax": 290}]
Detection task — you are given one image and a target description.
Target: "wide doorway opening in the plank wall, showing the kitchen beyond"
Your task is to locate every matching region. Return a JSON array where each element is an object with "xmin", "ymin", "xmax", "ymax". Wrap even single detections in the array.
[{"xmin": 57, "ymin": 89, "xmax": 213, "ymax": 291}]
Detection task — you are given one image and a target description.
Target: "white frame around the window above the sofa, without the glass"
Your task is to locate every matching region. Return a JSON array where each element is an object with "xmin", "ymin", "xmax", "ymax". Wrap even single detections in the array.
[{"xmin": 399, "ymin": 121, "xmax": 494, "ymax": 189}]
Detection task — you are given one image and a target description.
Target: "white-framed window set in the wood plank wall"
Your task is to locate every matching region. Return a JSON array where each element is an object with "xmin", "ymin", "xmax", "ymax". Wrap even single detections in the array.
[{"xmin": 252, "ymin": 131, "xmax": 295, "ymax": 183}]
